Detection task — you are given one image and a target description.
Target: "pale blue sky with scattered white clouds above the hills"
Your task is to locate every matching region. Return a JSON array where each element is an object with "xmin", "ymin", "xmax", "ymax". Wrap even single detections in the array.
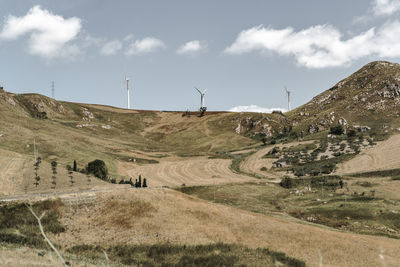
[{"xmin": 0, "ymin": 0, "xmax": 400, "ymax": 112}]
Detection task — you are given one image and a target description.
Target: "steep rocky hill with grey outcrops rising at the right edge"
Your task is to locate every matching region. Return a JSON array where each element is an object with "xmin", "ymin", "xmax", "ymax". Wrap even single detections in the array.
[{"xmin": 288, "ymin": 61, "xmax": 400, "ymax": 138}]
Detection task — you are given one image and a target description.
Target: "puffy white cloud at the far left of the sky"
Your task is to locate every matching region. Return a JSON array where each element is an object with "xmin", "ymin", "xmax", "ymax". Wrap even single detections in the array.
[{"xmin": 0, "ymin": 6, "xmax": 82, "ymax": 58}]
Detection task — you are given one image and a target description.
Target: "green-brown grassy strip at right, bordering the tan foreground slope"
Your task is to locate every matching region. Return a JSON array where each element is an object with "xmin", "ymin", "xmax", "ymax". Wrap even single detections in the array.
[{"xmin": 180, "ymin": 183, "xmax": 400, "ymax": 238}]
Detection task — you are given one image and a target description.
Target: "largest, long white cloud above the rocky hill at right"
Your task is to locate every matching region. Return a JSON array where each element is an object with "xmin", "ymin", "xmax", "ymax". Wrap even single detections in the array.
[{"xmin": 225, "ymin": 21, "xmax": 400, "ymax": 68}]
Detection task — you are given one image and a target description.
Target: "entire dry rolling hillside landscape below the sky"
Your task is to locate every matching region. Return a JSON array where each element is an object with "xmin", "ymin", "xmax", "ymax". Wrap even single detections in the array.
[{"xmin": 0, "ymin": 62, "xmax": 400, "ymax": 266}]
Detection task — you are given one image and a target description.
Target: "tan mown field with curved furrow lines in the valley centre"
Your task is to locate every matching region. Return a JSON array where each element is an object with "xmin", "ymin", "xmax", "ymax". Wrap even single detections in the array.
[{"xmin": 118, "ymin": 157, "xmax": 254, "ymax": 186}]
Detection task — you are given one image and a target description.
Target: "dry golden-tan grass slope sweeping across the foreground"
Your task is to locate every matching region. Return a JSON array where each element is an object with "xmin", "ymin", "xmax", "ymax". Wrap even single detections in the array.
[{"xmin": 52, "ymin": 189, "xmax": 400, "ymax": 266}]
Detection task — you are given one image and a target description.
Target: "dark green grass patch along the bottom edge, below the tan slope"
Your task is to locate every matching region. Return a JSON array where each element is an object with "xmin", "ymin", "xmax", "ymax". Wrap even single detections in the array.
[{"xmin": 68, "ymin": 243, "xmax": 305, "ymax": 267}]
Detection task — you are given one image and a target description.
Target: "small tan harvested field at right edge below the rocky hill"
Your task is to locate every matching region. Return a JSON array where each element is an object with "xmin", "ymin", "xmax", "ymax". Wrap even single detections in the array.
[{"xmin": 337, "ymin": 134, "xmax": 400, "ymax": 174}]
